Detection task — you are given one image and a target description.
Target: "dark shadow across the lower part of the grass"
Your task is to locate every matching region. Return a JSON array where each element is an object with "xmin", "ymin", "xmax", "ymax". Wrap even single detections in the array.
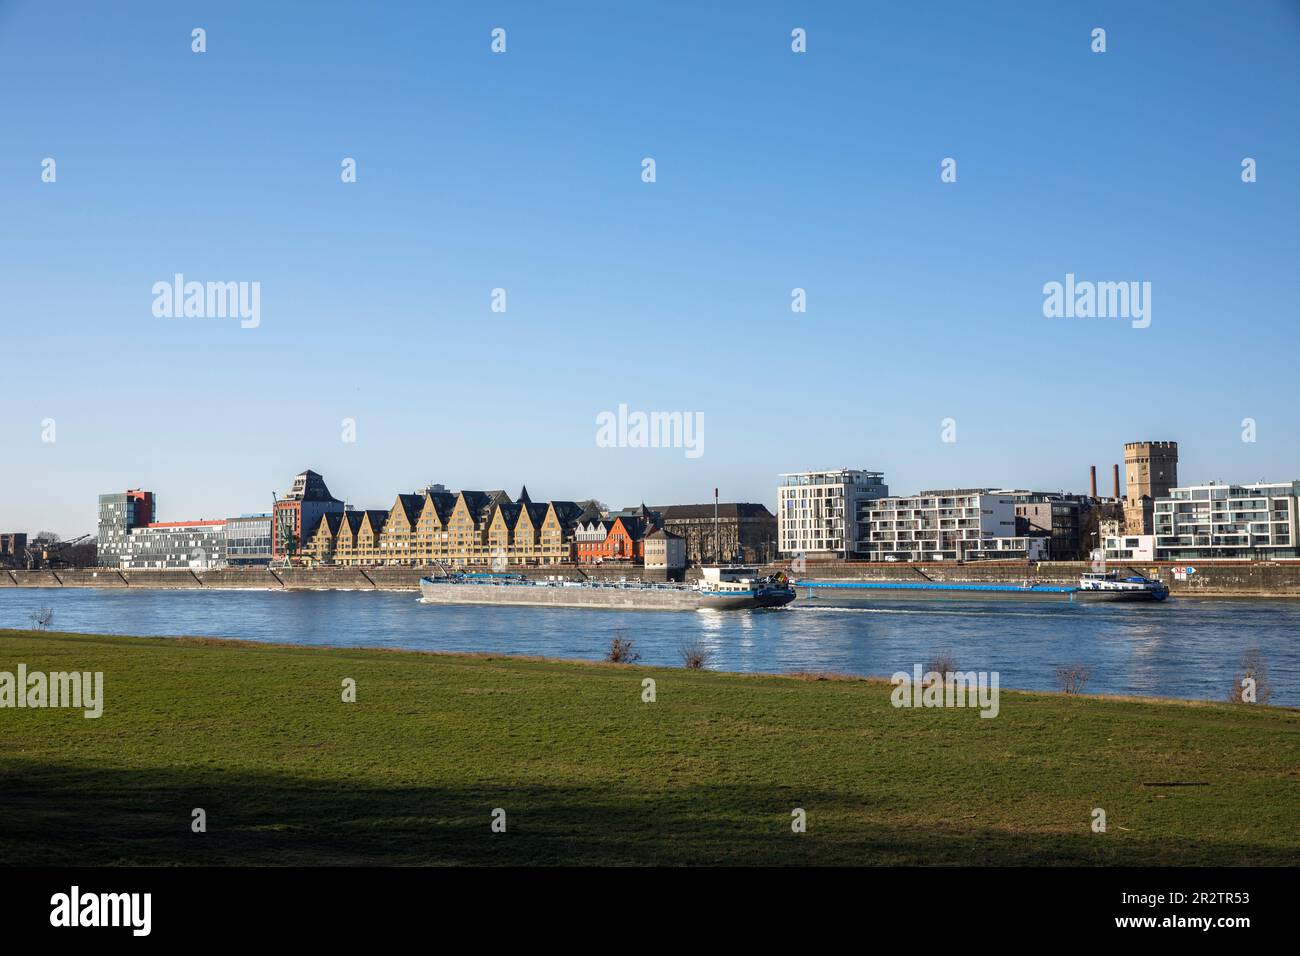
[{"xmin": 0, "ymin": 760, "xmax": 1296, "ymax": 866}]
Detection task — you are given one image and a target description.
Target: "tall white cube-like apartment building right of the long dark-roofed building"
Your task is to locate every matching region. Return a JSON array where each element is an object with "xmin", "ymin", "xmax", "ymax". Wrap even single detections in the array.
[{"xmin": 776, "ymin": 468, "xmax": 889, "ymax": 558}]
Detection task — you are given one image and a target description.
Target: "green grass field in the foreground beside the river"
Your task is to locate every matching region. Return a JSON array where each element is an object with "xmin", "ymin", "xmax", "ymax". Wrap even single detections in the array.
[{"xmin": 0, "ymin": 631, "xmax": 1300, "ymax": 865}]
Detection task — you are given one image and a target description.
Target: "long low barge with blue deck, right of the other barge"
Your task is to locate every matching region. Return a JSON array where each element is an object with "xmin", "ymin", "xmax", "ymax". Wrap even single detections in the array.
[{"xmin": 794, "ymin": 571, "xmax": 1169, "ymax": 606}]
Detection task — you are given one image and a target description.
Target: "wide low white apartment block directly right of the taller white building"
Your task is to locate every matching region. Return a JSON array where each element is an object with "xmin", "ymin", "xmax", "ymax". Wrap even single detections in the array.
[{"xmin": 857, "ymin": 489, "xmax": 1049, "ymax": 562}]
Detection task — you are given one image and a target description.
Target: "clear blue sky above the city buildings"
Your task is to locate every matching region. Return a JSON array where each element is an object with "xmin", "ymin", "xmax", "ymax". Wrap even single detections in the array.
[{"xmin": 0, "ymin": 0, "xmax": 1300, "ymax": 536}]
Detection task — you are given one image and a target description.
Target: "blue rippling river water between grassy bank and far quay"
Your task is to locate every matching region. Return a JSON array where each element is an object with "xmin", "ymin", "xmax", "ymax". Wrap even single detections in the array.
[{"xmin": 0, "ymin": 588, "xmax": 1300, "ymax": 706}]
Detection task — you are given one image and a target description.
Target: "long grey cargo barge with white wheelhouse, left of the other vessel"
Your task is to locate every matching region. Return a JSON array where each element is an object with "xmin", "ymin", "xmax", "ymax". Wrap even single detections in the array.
[{"xmin": 420, "ymin": 567, "xmax": 794, "ymax": 611}]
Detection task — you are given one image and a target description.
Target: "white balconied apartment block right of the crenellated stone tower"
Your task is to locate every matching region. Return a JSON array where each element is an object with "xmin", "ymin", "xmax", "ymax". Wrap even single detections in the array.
[{"xmin": 1153, "ymin": 481, "xmax": 1300, "ymax": 561}]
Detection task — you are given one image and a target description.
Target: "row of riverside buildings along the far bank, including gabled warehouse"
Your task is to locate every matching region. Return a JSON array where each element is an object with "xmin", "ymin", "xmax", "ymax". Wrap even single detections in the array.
[{"xmin": 65, "ymin": 441, "xmax": 1300, "ymax": 571}]
